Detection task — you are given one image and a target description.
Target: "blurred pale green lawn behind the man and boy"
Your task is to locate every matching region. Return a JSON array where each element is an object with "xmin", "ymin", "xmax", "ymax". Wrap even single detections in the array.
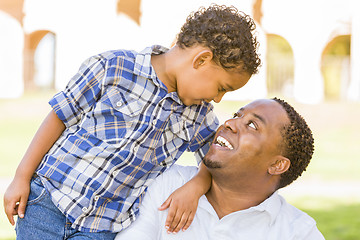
[{"xmin": 0, "ymin": 92, "xmax": 360, "ymax": 240}]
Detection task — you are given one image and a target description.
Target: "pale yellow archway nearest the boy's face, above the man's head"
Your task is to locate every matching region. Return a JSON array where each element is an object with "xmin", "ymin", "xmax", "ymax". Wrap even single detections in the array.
[{"xmin": 266, "ymin": 34, "xmax": 294, "ymax": 96}]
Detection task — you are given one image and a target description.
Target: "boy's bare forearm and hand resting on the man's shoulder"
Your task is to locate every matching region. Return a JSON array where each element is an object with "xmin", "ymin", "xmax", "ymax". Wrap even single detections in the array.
[{"xmin": 159, "ymin": 163, "xmax": 211, "ymax": 232}]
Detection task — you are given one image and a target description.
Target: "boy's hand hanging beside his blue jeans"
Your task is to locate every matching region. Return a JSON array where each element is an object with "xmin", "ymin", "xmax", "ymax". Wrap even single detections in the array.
[{"xmin": 4, "ymin": 179, "xmax": 30, "ymax": 225}]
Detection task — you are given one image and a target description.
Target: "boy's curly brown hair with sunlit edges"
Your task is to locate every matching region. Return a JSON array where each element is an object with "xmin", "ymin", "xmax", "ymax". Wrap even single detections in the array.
[{"xmin": 176, "ymin": 4, "xmax": 261, "ymax": 75}]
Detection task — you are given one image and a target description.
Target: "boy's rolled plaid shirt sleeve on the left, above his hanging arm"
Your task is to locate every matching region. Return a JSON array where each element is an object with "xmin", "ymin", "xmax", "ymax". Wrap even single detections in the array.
[{"xmin": 49, "ymin": 55, "xmax": 105, "ymax": 127}]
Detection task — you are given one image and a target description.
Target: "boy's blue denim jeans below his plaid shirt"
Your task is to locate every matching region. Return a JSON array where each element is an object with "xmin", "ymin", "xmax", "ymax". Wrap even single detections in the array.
[{"xmin": 16, "ymin": 176, "xmax": 116, "ymax": 240}]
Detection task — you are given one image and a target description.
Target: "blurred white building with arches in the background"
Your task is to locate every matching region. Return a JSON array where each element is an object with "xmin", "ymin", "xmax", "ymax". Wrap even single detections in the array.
[{"xmin": 0, "ymin": 0, "xmax": 360, "ymax": 103}]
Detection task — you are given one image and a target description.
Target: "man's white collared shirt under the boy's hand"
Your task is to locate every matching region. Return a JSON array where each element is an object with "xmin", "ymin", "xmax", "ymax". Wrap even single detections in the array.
[{"xmin": 115, "ymin": 165, "xmax": 324, "ymax": 240}]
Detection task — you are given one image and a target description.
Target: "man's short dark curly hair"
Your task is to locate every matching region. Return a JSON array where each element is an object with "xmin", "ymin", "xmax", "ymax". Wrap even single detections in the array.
[{"xmin": 272, "ymin": 97, "xmax": 314, "ymax": 188}]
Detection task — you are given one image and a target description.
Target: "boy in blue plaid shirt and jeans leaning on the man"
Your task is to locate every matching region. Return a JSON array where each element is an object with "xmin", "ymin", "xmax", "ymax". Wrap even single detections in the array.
[{"xmin": 4, "ymin": 5, "xmax": 260, "ymax": 239}]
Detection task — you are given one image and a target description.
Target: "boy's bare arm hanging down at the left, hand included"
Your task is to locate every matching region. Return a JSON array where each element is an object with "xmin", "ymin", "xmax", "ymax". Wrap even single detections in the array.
[{"xmin": 4, "ymin": 111, "xmax": 65, "ymax": 225}]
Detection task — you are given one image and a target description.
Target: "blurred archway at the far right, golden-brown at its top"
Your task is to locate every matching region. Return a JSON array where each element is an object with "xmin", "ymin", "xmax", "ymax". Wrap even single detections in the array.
[{"xmin": 321, "ymin": 35, "xmax": 351, "ymax": 100}]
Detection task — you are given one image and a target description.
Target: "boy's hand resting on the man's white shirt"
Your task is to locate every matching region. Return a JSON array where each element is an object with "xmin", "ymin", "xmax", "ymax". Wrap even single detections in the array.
[{"xmin": 159, "ymin": 184, "xmax": 201, "ymax": 233}]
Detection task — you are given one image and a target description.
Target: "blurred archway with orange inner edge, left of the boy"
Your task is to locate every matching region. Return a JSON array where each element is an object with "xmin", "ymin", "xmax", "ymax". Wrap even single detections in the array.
[{"xmin": 24, "ymin": 30, "xmax": 56, "ymax": 90}]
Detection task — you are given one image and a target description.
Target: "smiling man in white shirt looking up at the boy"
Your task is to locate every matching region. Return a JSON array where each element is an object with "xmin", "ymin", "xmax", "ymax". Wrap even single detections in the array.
[{"xmin": 116, "ymin": 98, "xmax": 324, "ymax": 240}]
